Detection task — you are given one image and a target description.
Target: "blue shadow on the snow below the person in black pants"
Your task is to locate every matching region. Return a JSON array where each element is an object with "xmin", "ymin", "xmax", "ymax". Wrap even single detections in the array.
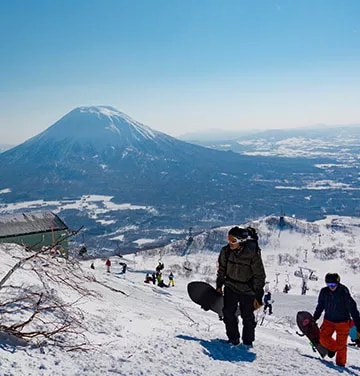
[{"xmin": 176, "ymin": 334, "xmax": 256, "ymax": 362}]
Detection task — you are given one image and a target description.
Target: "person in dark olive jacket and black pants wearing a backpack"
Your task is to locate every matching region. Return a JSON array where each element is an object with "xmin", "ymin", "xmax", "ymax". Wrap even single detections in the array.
[{"xmin": 216, "ymin": 226, "xmax": 266, "ymax": 348}]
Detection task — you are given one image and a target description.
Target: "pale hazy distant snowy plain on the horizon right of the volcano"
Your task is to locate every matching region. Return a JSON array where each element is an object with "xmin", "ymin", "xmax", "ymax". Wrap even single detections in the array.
[{"xmin": 180, "ymin": 124, "xmax": 360, "ymax": 159}]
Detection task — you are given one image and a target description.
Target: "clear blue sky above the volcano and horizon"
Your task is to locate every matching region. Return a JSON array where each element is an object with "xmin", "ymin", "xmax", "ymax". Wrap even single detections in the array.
[{"xmin": 0, "ymin": 0, "xmax": 360, "ymax": 143}]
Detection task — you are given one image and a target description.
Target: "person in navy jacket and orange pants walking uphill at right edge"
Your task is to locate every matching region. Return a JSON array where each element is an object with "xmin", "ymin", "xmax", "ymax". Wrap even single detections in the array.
[{"xmin": 313, "ymin": 273, "xmax": 360, "ymax": 367}]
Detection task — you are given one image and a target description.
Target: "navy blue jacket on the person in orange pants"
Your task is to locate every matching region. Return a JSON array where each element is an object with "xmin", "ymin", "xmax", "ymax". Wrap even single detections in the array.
[{"xmin": 313, "ymin": 283, "xmax": 360, "ymax": 331}]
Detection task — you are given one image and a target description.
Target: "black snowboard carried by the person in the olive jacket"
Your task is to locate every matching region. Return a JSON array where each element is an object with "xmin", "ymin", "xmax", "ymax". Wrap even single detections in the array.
[{"xmin": 188, "ymin": 281, "xmax": 240, "ymax": 319}]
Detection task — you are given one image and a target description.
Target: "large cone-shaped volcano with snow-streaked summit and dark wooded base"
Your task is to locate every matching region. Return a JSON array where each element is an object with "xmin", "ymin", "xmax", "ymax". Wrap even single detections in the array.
[{"xmin": 0, "ymin": 106, "xmax": 278, "ymax": 204}]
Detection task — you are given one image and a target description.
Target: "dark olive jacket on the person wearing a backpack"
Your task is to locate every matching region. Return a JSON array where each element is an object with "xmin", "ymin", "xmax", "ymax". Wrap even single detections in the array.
[{"xmin": 216, "ymin": 240, "xmax": 266, "ymax": 302}]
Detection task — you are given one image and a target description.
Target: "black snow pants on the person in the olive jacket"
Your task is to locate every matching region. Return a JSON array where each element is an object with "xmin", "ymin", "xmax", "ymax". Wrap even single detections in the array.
[{"xmin": 223, "ymin": 286, "xmax": 256, "ymax": 345}]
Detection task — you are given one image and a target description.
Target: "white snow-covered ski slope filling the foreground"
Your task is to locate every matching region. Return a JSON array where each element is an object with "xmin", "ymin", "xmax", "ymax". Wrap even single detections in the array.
[{"xmin": 0, "ymin": 217, "xmax": 360, "ymax": 376}]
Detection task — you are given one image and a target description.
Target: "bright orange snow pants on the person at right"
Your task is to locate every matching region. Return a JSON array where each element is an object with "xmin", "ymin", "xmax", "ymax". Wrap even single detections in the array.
[{"xmin": 320, "ymin": 320, "xmax": 350, "ymax": 366}]
